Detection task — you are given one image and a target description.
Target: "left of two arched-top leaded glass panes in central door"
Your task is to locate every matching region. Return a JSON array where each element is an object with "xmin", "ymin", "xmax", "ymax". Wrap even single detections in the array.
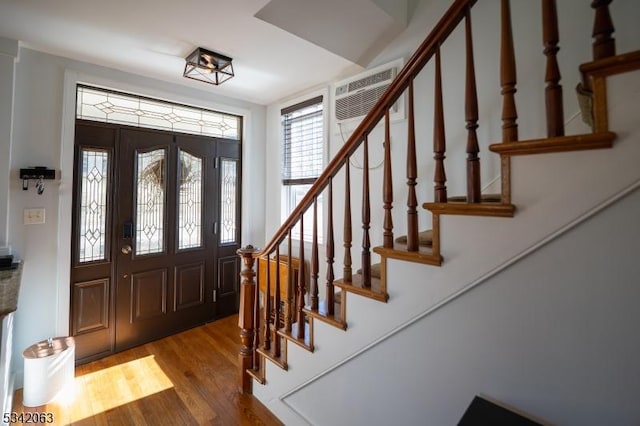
[{"xmin": 135, "ymin": 149, "xmax": 167, "ymax": 255}]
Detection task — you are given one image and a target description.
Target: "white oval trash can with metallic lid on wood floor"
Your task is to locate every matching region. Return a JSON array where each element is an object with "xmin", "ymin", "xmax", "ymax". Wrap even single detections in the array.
[{"xmin": 22, "ymin": 337, "xmax": 75, "ymax": 407}]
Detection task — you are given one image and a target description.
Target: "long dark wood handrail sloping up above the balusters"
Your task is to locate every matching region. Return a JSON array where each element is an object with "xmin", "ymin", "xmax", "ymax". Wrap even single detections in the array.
[{"xmin": 254, "ymin": 0, "xmax": 477, "ymax": 257}]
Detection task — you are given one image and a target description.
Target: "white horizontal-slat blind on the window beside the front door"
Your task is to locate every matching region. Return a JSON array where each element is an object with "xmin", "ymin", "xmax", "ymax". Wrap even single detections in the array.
[{"xmin": 280, "ymin": 96, "xmax": 324, "ymax": 185}]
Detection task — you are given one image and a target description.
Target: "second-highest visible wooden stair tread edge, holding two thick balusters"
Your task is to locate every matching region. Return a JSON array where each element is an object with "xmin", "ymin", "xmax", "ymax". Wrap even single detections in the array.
[{"xmin": 489, "ymin": 132, "xmax": 616, "ymax": 155}]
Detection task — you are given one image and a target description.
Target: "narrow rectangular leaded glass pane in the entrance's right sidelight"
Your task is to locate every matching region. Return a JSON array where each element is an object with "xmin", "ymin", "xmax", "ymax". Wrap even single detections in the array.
[{"xmin": 220, "ymin": 158, "xmax": 238, "ymax": 244}]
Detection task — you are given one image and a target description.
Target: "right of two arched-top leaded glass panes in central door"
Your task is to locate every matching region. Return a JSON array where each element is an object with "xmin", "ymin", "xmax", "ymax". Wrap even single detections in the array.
[{"xmin": 178, "ymin": 151, "xmax": 202, "ymax": 250}]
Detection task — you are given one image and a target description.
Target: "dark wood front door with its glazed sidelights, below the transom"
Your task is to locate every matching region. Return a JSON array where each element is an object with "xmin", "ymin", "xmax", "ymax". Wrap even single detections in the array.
[{"xmin": 71, "ymin": 121, "xmax": 240, "ymax": 360}]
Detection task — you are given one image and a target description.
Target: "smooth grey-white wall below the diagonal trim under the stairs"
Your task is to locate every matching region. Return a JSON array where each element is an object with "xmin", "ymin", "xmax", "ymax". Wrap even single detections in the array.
[{"xmin": 284, "ymin": 185, "xmax": 640, "ymax": 426}]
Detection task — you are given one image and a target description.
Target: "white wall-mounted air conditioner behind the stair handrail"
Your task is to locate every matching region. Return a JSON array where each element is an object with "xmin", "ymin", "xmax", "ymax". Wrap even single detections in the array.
[{"xmin": 333, "ymin": 59, "xmax": 405, "ymax": 130}]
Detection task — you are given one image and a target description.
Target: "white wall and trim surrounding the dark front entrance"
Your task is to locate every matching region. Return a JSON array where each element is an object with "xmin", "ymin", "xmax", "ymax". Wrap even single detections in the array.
[{"xmin": 3, "ymin": 48, "xmax": 265, "ymax": 381}]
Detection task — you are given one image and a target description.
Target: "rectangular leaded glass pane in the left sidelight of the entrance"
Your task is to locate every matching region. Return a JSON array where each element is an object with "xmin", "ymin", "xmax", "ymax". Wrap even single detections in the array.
[{"xmin": 78, "ymin": 148, "xmax": 109, "ymax": 263}]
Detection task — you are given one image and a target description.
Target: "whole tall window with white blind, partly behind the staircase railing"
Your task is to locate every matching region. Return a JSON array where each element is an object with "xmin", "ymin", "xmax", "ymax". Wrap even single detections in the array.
[{"xmin": 281, "ymin": 96, "xmax": 325, "ymax": 243}]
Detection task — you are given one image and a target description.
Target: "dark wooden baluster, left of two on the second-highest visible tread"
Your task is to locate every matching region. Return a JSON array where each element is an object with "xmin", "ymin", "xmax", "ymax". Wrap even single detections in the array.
[{"xmin": 500, "ymin": 0, "xmax": 518, "ymax": 142}]
